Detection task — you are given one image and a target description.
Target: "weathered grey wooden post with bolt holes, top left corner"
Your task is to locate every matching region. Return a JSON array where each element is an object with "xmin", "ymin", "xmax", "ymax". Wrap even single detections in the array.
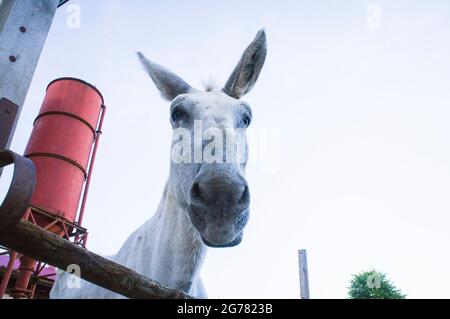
[{"xmin": 0, "ymin": 0, "xmax": 60, "ymax": 151}]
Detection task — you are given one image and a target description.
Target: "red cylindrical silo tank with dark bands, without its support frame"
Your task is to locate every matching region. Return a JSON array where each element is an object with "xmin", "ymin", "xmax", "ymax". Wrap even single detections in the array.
[{"xmin": 24, "ymin": 78, "xmax": 103, "ymax": 232}]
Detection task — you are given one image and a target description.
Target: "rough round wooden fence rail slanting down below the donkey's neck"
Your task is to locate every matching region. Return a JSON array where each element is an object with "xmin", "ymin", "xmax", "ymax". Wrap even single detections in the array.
[{"xmin": 0, "ymin": 220, "xmax": 191, "ymax": 299}]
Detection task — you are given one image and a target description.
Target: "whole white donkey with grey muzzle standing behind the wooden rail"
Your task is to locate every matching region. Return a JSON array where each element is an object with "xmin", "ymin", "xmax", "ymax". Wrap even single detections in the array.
[{"xmin": 50, "ymin": 30, "xmax": 266, "ymax": 298}]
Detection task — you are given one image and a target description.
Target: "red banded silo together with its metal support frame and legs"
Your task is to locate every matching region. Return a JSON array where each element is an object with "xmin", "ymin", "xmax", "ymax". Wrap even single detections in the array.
[{"xmin": 0, "ymin": 78, "xmax": 106, "ymax": 298}]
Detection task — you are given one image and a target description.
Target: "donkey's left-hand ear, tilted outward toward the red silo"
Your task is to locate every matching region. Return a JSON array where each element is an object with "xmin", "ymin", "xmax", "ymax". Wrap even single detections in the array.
[{"xmin": 137, "ymin": 52, "xmax": 193, "ymax": 101}]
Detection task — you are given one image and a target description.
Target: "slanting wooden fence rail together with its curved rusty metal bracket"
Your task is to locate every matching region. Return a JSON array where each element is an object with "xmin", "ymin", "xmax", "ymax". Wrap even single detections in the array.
[{"xmin": 0, "ymin": 151, "xmax": 191, "ymax": 299}]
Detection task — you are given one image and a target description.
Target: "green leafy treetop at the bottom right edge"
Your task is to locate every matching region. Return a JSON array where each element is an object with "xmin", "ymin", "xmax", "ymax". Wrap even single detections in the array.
[{"xmin": 348, "ymin": 270, "xmax": 406, "ymax": 299}]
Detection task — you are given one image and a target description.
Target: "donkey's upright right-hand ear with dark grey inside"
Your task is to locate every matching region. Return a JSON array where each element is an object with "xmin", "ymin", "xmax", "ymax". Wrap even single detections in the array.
[{"xmin": 223, "ymin": 29, "xmax": 267, "ymax": 99}]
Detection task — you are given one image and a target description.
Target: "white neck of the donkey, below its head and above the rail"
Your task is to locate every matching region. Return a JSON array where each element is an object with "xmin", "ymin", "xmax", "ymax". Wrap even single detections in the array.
[{"xmin": 150, "ymin": 182, "xmax": 207, "ymax": 293}]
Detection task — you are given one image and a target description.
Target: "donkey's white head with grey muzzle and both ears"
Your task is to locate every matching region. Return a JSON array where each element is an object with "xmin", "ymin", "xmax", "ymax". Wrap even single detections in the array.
[{"xmin": 138, "ymin": 30, "xmax": 266, "ymax": 247}]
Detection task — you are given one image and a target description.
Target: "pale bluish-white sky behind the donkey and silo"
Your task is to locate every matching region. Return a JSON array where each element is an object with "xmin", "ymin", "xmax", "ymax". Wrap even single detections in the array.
[{"xmin": 2, "ymin": 0, "xmax": 450, "ymax": 298}]
